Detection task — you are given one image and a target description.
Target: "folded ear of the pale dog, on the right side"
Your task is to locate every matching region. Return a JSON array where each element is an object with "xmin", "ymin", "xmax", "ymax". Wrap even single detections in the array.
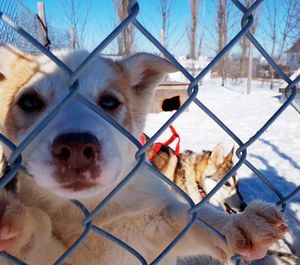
[{"xmin": 120, "ymin": 53, "xmax": 177, "ymax": 94}]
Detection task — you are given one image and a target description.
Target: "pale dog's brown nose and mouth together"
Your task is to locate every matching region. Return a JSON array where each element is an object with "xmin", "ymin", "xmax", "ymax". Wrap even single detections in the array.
[{"xmin": 52, "ymin": 133, "xmax": 101, "ymax": 191}]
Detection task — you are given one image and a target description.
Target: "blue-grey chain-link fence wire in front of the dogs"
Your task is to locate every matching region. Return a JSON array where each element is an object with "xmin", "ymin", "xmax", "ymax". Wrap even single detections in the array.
[{"xmin": 0, "ymin": 0, "xmax": 300, "ymax": 265}]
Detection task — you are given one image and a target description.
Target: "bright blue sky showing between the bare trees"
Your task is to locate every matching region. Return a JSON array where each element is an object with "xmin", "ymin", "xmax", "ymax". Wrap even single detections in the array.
[{"xmin": 23, "ymin": 0, "xmax": 296, "ymax": 56}]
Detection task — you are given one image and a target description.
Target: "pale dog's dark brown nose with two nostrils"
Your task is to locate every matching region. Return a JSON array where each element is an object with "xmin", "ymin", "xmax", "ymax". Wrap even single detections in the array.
[{"xmin": 52, "ymin": 133, "xmax": 100, "ymax": 171}]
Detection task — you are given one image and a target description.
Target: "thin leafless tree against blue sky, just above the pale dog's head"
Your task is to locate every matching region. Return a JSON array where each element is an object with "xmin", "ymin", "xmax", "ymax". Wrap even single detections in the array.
[{"xmin": 62, "ymin": 0, "xmax": 92, "ymax": 48}]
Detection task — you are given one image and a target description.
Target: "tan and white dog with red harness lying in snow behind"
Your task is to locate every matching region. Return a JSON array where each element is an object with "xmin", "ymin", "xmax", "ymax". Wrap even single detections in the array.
[{"xmin": 143, "ymin": 134, "xmax": 246, "ymax": 213}]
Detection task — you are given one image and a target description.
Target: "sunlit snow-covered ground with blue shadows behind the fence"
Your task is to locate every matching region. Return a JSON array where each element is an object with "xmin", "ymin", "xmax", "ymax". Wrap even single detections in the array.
[{"xmin": 145, "ymin": 79, "xmax": 300, "ymax": 254}]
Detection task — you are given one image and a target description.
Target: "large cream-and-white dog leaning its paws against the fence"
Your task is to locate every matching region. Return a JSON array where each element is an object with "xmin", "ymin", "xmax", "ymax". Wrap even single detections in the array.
[{"xmin": 0, "ymin": 46, "xmax": 288, "ymax": 265}]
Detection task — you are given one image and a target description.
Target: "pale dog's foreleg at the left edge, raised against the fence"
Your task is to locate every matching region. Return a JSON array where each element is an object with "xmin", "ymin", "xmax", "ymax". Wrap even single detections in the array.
[{"xmin": 0, "ymin": 190, "xmax": 64, "ymax": 265}]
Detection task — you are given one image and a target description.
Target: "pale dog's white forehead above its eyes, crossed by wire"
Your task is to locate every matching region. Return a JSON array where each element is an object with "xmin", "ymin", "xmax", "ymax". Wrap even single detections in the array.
[{"xmin": 29, "ymin": 51, "xmax": 120, "ymax": 98}]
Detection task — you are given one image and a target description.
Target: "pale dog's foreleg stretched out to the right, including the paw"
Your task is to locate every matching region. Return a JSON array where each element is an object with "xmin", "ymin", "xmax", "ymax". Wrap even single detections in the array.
[{"xmin": 169, "ymin": 201, "xmax": 288, "ymax": 262}]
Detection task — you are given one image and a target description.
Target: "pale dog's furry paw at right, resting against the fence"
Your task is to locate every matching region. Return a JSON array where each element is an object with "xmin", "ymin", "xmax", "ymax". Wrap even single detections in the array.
[{"xmin": 224, "ymin": 201, "xmax": 289, "ymax": 261}]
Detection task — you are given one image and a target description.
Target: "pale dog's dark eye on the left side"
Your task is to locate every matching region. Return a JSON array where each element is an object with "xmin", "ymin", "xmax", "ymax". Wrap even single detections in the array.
[{"xmin": 17, "ymin": 92, "xmax": 45, "ymax": 113}]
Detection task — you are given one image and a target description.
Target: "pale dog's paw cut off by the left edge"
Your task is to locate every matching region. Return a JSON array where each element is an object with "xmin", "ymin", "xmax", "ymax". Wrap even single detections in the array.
[{"xmin": 0, "ymin": 190, "xmax": 30, "ymax": 253}]
